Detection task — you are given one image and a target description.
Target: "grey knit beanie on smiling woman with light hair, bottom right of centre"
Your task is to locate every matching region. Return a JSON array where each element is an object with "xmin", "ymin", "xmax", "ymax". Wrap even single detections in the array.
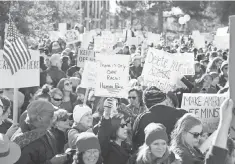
[{"xmin": 144, "ymin": 123, "xmax": 168, "ymax": 146}]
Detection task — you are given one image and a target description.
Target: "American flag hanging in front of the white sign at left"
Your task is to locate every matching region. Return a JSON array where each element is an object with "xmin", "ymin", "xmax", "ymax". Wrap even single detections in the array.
[{"xmin": 3, "ymin": 18, "xmax": 31, "ymax": 74}]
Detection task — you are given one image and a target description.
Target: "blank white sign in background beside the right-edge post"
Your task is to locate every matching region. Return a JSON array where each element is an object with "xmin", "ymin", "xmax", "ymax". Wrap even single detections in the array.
[{"xmin": 214, "ymin": 34, "xmax": 229, "ymax": 50}]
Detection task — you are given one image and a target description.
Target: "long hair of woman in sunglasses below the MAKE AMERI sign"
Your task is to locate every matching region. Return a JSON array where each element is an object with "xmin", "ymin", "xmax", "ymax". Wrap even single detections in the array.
[{"xmin": 170, "ymin": 113, "xmax": 202, "ymax": 154}]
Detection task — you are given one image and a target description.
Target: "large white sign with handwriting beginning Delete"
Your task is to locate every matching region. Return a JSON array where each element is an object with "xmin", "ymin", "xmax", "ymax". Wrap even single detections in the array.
[{"xmin": 142, "ymin": 48, "xmax": 195, "ymax": 92}]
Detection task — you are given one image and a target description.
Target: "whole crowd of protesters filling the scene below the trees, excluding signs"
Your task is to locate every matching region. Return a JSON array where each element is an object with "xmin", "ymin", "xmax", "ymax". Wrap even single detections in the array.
[{"xmin": 0, "ymin": 26, "xmax": 235, "ymax": 164}]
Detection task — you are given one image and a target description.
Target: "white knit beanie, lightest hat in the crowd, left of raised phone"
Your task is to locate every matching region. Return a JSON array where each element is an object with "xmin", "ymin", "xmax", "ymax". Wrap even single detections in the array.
[{"xmin": 73, "ymin": 105, "xmax": 92, "ymax": 123}]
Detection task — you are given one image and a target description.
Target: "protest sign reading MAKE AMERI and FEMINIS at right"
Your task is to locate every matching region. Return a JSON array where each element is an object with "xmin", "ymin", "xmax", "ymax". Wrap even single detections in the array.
[{"xmin": 181, "ymin": 93, "xmax": 227, "ymax": 133}]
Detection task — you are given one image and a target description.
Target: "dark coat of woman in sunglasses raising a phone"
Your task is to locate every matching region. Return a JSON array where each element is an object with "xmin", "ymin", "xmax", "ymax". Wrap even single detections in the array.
[{"xmin": 98, "ymin": 118, "xmax": 131, "ymax": 164}]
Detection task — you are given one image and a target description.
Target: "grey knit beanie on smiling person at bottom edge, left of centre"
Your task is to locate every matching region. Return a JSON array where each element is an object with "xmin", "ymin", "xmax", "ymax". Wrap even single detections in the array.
[{"xmin": 76, "ymin": 132, "xmax": 100, "ymax": 152}]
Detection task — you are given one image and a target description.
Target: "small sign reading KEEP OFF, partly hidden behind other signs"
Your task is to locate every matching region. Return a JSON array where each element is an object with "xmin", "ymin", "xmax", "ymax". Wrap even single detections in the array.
[{"xmin": 77, "ymin": 49, "xmax": 95, "ymax": 67}]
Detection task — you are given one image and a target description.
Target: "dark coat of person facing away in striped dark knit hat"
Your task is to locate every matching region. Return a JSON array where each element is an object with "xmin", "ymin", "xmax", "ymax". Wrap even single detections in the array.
[{"xmin": 132, "ymin": 105, "xmax": 186, "ymax": 151}]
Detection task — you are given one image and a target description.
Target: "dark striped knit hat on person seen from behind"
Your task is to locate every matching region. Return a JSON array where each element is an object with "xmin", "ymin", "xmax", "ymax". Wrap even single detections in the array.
[{"xmin": 143, "ymin": 86, "xmax": 166, "ymax": 108}]
